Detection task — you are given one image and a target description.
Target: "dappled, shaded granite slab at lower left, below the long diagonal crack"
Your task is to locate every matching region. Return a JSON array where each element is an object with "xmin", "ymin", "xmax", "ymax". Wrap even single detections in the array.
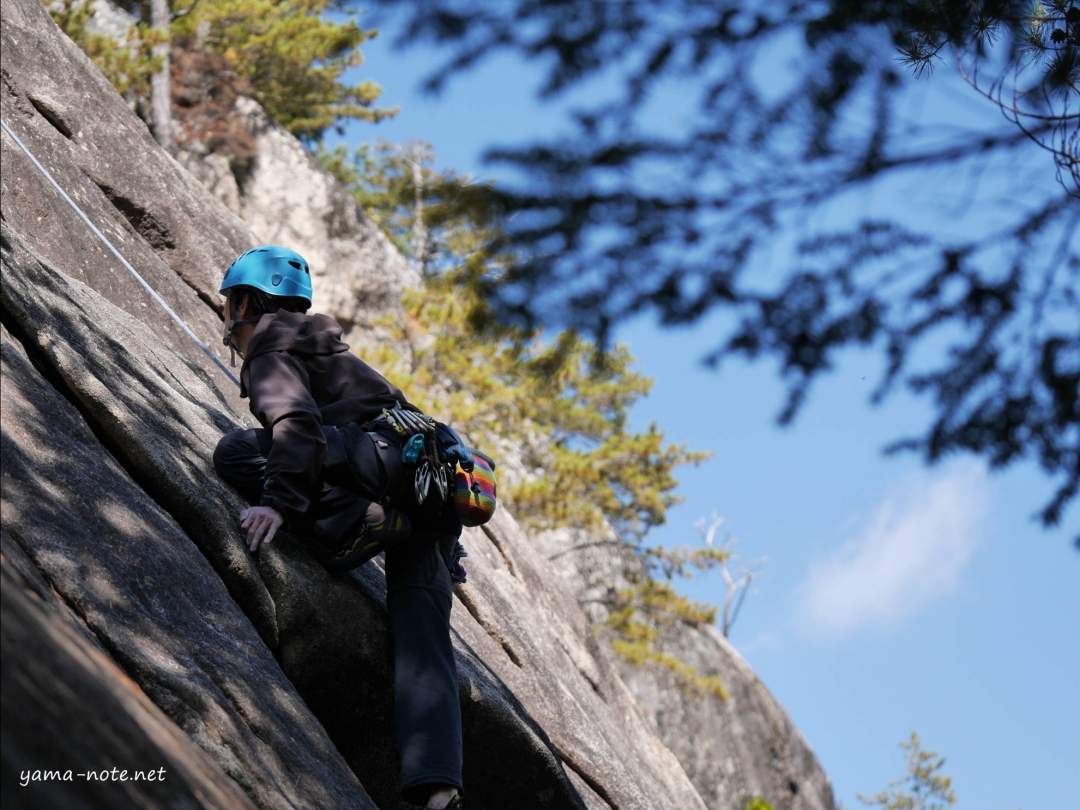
[{"xmin": 0, "ymin": 319, "xmax": 375, "ymax": 810}]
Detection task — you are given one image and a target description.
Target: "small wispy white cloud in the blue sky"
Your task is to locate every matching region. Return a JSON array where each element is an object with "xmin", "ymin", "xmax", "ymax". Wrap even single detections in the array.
[{"xmin": 797, "ymin": 462, "xmax": 988, "ymax": 636}]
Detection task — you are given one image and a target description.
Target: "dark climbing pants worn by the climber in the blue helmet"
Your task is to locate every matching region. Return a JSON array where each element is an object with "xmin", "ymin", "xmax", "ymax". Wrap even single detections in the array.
[{"xmin": 214, "ymin": 430, "xmax": 463, "ymax": 805}]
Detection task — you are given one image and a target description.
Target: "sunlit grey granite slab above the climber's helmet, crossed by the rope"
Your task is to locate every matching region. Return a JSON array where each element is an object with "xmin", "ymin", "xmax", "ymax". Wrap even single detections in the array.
[{"xmin": 0, "ymin": 2, "xmax": 253, "ymax": 315}]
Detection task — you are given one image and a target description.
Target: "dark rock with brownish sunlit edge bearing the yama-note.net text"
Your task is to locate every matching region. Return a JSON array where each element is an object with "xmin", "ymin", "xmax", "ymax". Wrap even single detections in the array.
[{"xmin": 0, "ymin": 542, "xmax": 256, "ymax": 810}]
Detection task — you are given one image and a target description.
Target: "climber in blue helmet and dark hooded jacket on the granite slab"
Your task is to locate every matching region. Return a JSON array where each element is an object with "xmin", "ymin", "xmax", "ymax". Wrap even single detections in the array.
[{"xmin": 214, "ymin": 245, "xmax": 464, "ymax": 810}]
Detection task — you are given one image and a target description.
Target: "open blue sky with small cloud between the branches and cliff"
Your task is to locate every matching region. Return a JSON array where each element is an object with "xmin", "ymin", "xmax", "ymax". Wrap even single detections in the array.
[{"xmin": 330, "ymin": 14, "xmax": 1080, "ymax": 810}]
